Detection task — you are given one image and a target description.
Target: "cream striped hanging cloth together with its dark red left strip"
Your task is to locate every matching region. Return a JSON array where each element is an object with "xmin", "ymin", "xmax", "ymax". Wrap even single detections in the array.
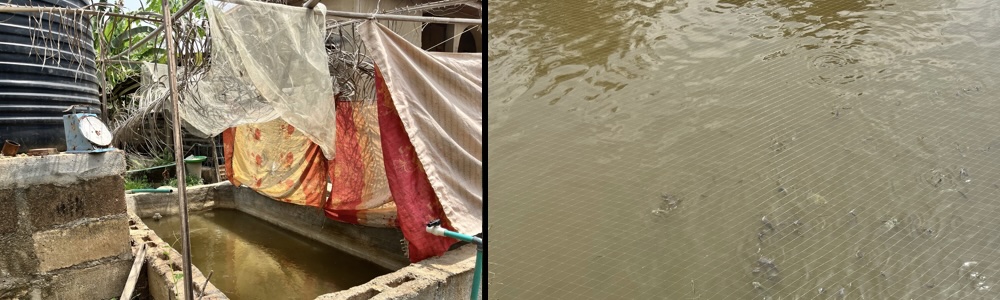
[{"xmin": 359, "ymin": 21, "xmax": 483, "ymax": 262}]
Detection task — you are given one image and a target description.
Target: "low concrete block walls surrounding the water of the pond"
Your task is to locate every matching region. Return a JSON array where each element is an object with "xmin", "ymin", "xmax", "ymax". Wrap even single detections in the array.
[{"xmin": 126, "ymin": 182, "xmax": 482, "ymax": 300}]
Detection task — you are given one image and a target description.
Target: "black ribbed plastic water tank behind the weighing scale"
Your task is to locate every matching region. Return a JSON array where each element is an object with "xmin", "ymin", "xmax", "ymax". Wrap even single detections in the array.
[{"xmin": 0, "ymin": 0, "xmax": 101, "ymax": 152}]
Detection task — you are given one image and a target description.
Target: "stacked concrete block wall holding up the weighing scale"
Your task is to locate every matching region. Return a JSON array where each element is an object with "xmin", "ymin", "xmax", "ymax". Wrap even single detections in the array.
[{"xmin": 0, "ymin": 151, "xmax": 132, "ymax": 299}]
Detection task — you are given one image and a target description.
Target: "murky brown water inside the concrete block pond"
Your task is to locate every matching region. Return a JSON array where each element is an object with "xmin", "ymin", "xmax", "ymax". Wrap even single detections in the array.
[{"xmin": 143, "ymin": 209, "xmax": 390, "ymax": 299}]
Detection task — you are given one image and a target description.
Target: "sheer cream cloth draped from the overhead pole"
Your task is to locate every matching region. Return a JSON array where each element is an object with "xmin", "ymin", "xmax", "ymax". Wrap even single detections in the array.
[{"xmin": 201, "ymin": 1, "xmax": 336, "ymax": 159}]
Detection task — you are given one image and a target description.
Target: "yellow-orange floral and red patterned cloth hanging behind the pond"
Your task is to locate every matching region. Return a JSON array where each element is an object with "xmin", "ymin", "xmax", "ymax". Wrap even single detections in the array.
[{"xmin": 222, "ymin": 101, "xmax": 398, "ymax": 228}]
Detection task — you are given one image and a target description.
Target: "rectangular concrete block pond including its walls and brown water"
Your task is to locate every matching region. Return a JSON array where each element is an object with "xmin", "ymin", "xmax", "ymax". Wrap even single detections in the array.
[{"xmin": 126, "ymin": 182, "xmax": 475, "ymax": 299}]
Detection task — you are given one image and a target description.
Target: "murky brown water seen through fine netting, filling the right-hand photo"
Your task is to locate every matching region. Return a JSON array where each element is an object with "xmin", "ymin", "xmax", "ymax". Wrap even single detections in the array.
[{"xmin": 487, "ymin": 0, "xmax": 1000, "ymax": 299}]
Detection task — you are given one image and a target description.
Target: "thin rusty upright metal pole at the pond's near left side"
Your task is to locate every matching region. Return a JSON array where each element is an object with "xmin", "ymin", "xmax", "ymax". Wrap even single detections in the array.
[{"xmin": 160, "ymin": 0, "xmax": 194, "ymax": 300}]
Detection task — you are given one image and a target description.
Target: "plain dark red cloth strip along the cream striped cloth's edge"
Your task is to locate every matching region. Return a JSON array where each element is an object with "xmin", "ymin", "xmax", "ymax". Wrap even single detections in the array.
[{"xmin": 376, "ymin": 68, "xmax": 456, "ymax": 262}]
